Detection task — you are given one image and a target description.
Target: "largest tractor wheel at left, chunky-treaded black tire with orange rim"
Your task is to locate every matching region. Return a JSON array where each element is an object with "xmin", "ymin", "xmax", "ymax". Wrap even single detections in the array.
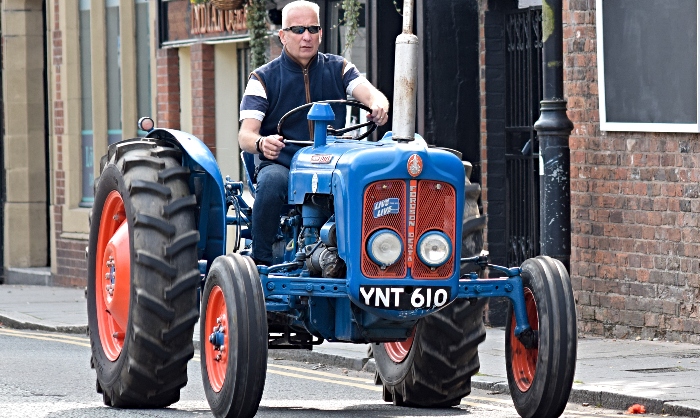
[{"xmin": 87, "ymin": 140, "xmax": 200, "ymax": 408}]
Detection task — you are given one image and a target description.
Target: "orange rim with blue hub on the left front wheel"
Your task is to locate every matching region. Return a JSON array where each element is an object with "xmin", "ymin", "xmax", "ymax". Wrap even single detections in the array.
[{"xmin": 204, "ymin": 286, "xmax": 229, "ymax": 393}]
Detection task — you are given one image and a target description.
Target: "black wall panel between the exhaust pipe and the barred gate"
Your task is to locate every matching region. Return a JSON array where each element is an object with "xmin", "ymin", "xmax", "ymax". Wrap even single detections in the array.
[{"xmin": 418, "ymin": 0, "xmax": 481, "ymax": 183}]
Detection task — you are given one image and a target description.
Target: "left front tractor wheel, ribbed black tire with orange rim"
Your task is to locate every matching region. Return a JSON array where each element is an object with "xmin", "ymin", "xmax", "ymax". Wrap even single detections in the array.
[{"xmin": 200, "ymin": 254, "xmax": 267, "ymax": 418}]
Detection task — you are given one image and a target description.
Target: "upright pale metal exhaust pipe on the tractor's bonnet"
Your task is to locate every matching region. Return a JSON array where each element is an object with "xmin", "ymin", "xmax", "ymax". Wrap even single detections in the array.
[{"xmin": 391, "ymin": 0, "xmax": 418, "ymax": 141}]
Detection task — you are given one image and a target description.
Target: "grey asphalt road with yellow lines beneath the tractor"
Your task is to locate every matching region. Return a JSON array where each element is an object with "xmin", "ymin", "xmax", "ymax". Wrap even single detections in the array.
[{"xmin": 0, "ymin": 328, "xmax": 680, "ymax": 418}]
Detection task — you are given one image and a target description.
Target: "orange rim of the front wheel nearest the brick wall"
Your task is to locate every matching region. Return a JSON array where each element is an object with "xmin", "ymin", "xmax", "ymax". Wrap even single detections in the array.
[{"xmin": 510, "ymin": 288, "xmax": 539, "ymax": 392}]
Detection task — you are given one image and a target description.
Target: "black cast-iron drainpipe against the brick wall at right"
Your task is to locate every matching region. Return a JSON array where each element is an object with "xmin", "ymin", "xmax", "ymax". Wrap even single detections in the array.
[{"xmin": 535, "ymin": 0, "xmax": 574, "ymax": 270}]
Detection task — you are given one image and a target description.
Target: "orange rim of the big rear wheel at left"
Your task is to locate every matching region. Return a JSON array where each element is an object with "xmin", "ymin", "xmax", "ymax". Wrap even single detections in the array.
[{"xmin": 95, "ymin": 191, "xmax": 131, "ymax": 361}]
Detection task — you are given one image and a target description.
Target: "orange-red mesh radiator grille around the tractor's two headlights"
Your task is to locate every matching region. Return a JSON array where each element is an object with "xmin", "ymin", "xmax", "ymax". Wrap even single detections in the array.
[{"xmin": 361, "ymin": 180, "xmax": 461, "ymax": 279}]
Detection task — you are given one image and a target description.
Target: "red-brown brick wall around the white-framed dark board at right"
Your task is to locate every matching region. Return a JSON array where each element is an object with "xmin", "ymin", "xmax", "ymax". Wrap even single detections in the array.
[{"xmin": 563, "ymin": 0, "xmax": 700, "ymax": 343}]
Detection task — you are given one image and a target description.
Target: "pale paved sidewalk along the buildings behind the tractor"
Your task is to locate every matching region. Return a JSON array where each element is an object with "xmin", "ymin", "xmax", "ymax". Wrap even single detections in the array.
[{"xmin": 0, "ymin": 284, "xmax": 700, "ymax": 418}]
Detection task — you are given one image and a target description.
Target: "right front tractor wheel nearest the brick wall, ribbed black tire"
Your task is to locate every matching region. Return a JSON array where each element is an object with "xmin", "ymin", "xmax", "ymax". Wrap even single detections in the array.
[{"xmin": 506, "ymin": 256, "xmax": 577, "ymax": 418}]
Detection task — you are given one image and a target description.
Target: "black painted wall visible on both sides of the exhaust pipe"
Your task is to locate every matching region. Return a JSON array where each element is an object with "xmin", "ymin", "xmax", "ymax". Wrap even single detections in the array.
[{"xmin": 367, "ymin": 0, "xmax": 481, "ymax": 182}]
